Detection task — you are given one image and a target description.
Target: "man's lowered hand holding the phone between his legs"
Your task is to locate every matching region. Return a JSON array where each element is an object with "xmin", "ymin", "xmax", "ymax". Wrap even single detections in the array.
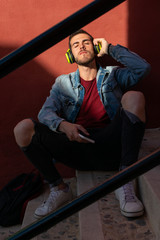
[{"xmin": 58, "ymin": 121, "xmax": 89, "ymax": 143}]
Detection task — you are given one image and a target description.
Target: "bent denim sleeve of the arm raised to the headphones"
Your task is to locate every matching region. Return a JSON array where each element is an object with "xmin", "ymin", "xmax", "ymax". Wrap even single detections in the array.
[{"xmin": 109, "ymin": 45, "xmax": 150, "ymax": 91}]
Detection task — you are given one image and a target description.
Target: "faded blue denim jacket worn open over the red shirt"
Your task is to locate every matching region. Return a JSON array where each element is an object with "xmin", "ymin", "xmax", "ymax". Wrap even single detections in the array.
[{"xmin": 38, "ymin": 45, "xmax": 150, "ymax": 131}]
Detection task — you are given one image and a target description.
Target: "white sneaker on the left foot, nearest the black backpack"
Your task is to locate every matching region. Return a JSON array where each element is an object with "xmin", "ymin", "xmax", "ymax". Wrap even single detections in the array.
[{"xmin": 34, "ymin": 186, "xmax": 73, "ymax": 218}]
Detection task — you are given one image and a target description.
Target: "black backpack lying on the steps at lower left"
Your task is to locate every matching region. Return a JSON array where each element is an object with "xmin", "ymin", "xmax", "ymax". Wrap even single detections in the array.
[{"xmin": 0, "ymin": 171, "xmax": 43, "ymax": 227}]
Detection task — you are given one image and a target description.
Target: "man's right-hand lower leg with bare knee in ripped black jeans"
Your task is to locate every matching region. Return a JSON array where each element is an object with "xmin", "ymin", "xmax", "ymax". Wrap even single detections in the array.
[{"xmin": 121, "ymin": 91, "xmax": 146, "ymax": 168}]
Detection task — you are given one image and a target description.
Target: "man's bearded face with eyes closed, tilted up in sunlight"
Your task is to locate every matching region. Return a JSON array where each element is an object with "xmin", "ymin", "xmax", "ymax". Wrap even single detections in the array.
[{"xmin": 70, "ymin": 33, "xmax": 95, "ymax": 66}]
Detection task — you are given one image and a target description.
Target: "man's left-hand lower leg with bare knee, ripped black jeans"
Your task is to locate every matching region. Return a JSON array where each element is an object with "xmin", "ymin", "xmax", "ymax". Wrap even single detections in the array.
[{"xmin": 14, "ymin": 119, "xmax": 63, "ymax": 187}]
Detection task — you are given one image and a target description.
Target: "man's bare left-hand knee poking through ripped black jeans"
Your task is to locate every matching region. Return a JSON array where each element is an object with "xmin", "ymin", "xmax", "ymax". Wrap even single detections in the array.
[{"xmin": 14, "ymin": 119, "xmax": 35, "ymax": 147}]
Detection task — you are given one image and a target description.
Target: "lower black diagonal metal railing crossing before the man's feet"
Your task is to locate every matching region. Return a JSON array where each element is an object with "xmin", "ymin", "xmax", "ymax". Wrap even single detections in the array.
[{"xmin": 8, "ymin": 148, "xmax": 160, "ymax": 240}]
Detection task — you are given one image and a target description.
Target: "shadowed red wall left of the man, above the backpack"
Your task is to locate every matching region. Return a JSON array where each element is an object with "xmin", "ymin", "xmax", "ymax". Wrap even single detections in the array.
[{"xmin": 0, "ymin": 46, "xmax": 74, "ymax": 188}]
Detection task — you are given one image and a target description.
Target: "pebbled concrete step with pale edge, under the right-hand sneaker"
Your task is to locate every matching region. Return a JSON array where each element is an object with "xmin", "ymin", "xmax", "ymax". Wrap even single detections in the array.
[{"xmin": 77, "ymin": 171, "xmax": 158, "ymax": 240}]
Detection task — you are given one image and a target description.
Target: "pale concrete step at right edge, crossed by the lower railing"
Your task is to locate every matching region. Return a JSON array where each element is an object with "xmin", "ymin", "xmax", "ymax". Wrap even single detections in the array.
[{"xmin": 138, "ymin": 128, "xmax": 160, "ymax": 240}]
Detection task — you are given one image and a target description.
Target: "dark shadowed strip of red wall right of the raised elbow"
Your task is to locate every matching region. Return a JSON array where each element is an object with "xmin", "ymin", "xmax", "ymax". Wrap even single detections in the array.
[{"xmin": 128, "ymin": 0, "xmax": 160, "ymax": 128}]
